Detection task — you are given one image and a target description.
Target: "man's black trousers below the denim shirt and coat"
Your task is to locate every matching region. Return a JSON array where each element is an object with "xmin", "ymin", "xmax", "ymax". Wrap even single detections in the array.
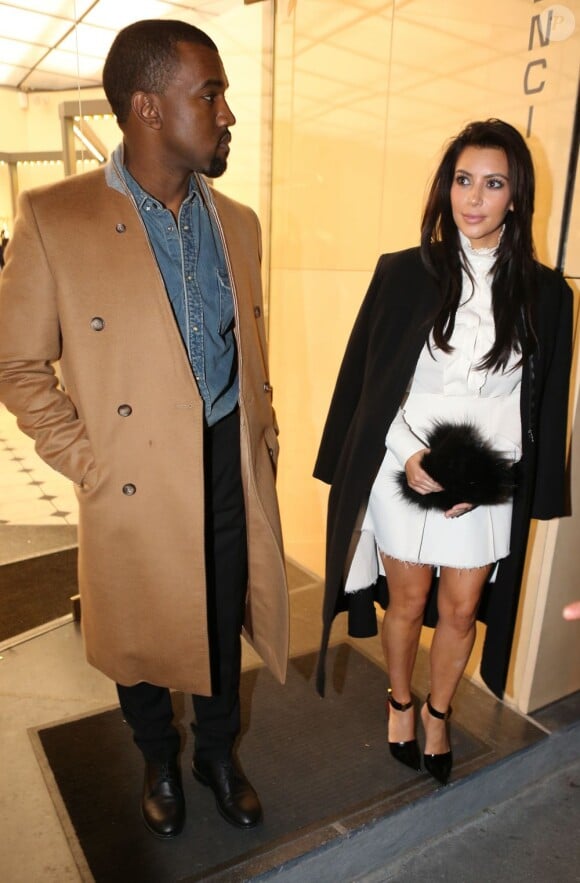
[{"xmin": 117, "ymin": 408, "xmax": 248, "ymax": 760}]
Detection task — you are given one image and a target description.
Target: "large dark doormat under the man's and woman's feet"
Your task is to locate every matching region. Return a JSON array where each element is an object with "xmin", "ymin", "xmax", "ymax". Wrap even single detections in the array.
[{"xmin": 31, "ymin": 644, "xmax": 486, "ymax": 883}]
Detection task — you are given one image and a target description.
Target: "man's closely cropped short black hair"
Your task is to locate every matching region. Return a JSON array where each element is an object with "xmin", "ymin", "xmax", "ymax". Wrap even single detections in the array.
[{"xmin": 103, "ymin": 19, "xmax": 218, "ymax": 126}]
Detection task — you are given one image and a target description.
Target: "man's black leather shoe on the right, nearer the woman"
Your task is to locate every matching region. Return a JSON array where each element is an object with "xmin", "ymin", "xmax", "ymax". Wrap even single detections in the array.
[{"xmin": 191, "ymin": 757, "xmax": 262, "ymax": 828}]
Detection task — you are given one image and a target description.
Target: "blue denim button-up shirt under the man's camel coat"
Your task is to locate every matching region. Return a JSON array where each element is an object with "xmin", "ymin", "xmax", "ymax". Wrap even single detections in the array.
[{"xmin": 122, "ymin": 156, "xmax": 239, "ymax": 426}]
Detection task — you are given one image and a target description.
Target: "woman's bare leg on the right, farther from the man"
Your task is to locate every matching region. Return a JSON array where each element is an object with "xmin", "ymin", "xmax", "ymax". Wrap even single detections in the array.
[{"xmin": 421, "ymin": 565, "xmax": 491, "ymax": 754}]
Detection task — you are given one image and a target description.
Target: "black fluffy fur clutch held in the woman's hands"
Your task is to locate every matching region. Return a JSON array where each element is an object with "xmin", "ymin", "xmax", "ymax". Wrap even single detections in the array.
[{"xmin": 397, "ymin": 421, "xmax": 516, "ymax": 512}]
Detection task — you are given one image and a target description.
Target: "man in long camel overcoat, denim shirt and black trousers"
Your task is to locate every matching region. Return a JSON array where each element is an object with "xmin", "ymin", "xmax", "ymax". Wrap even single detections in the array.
[{"xmin": 0, "ymin": 20, "xmax": 288, "ymax": 838}]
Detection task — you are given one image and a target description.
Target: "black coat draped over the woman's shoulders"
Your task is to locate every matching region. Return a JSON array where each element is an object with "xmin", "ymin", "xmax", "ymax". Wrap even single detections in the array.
[{"xmin": 314, "ymin": 248, "xmax": 572, "ymax": 697}]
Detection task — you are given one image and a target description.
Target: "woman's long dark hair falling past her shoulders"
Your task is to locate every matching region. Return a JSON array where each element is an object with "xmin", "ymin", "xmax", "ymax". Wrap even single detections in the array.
[{"xmin": 421, "ymin": 119, "xmax": 536, "ymax": 370}]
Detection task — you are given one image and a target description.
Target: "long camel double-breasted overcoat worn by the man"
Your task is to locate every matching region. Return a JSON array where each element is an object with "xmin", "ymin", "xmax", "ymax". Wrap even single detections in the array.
[{"xmin": 0, "ymin": 162, "xmax": 289, "ymax": 695}]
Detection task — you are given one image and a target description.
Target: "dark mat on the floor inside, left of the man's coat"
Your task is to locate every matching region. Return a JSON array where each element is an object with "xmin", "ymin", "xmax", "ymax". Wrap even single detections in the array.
[{"xmin": 0, "ymin": 548, "xmax": 78, "ymax": 641}]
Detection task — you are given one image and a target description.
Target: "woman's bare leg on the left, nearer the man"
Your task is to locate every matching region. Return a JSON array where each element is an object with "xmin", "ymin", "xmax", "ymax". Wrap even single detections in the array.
[{"xmin": 381, "ymin": 555, "xmax": 433, "ymax": 742}]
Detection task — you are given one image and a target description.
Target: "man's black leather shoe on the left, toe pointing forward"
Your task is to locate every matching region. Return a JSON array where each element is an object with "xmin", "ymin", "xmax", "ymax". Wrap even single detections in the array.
[{"xmin": 141, "ymin": 760, "xmax": 185, "ymax": 840}]
